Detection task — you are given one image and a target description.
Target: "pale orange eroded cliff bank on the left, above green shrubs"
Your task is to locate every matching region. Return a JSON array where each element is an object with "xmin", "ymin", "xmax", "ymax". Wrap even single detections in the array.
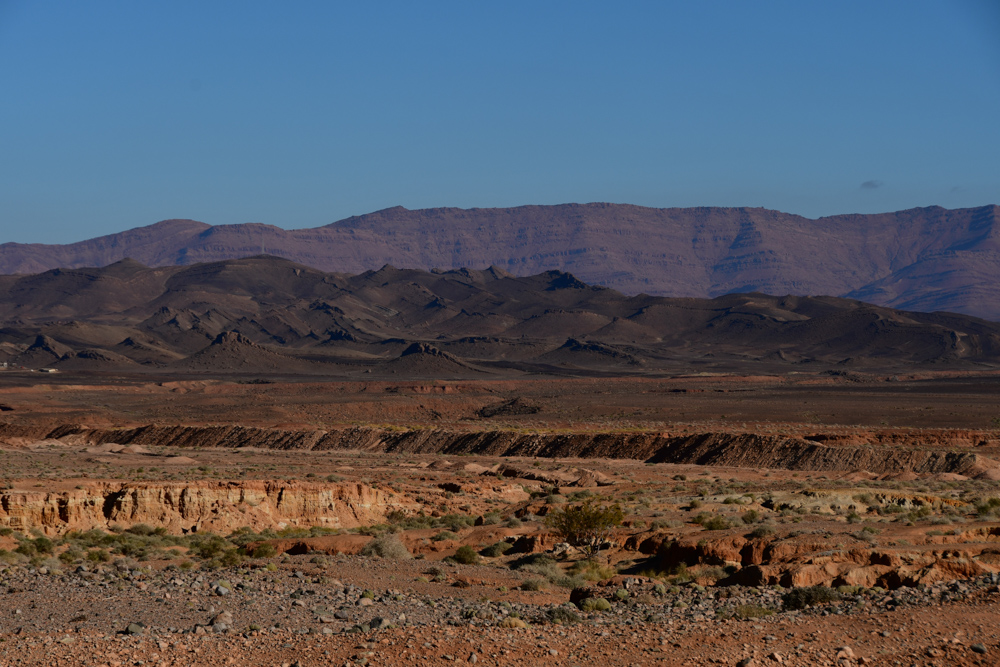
[{"xmin": 0, "ymin": 481, "xmax": 411, "ymax": 534}]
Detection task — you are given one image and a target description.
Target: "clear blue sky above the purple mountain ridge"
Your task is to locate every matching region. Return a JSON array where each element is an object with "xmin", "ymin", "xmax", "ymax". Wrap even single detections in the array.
[{"xmin": 0, "ymin": 0, "xmax": 1000, "ymax": 243}]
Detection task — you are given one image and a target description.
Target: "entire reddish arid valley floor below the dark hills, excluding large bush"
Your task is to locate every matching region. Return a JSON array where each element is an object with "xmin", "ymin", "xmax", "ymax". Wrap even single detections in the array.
[{"xmin": 0, "ymin": 369, "xmax": 1000, "ymax": 667}]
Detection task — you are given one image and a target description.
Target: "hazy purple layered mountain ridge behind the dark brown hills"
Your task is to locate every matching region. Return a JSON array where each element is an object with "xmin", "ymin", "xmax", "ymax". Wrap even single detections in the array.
[{"xmin": 0, "ymin": 204, "xmax": 1000, "ymax": 320}]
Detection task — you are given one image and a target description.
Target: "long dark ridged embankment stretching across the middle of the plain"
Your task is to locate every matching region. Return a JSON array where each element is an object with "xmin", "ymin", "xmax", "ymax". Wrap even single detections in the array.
[{"xmin": 0, "ymin": 424, "xmax": 1000, "ymax": 479}]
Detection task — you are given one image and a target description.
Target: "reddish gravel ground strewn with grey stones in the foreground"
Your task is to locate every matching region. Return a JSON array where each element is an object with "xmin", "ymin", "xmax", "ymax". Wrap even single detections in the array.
[{"xmin": 0, "ymin": 557, "xmax": 1000, "ymax": 667}]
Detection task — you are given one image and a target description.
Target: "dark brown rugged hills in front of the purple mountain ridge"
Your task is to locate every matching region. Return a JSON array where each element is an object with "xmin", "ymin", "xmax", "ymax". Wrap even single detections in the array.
[{"xmin": 0, "ymin": 256, "xmax": 1000, "ymax": 378}]
